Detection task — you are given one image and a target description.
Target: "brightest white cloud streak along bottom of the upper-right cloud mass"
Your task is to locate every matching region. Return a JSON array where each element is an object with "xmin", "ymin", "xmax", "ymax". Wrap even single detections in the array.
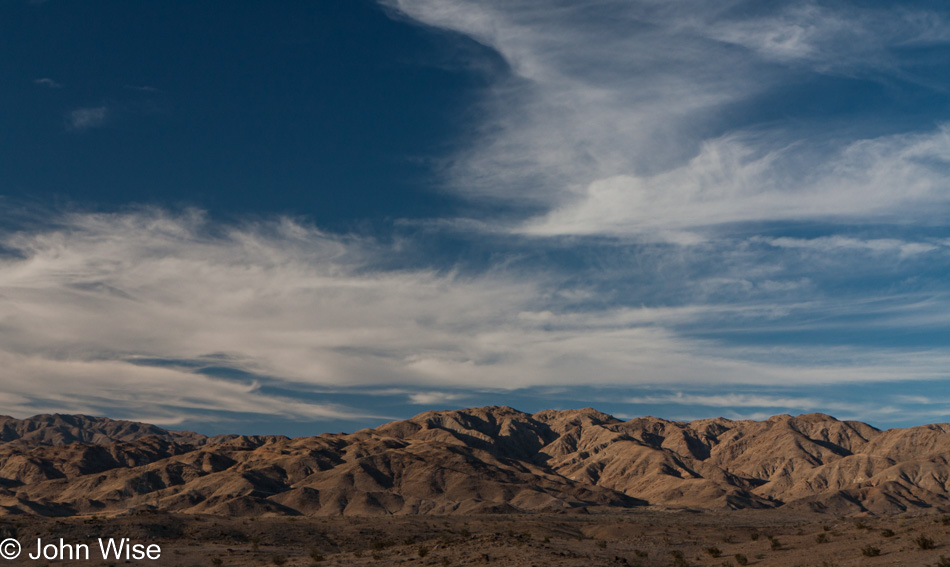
[{"xmin": 521, "ymin": 127, "xmax": 950, "ymax": 236}]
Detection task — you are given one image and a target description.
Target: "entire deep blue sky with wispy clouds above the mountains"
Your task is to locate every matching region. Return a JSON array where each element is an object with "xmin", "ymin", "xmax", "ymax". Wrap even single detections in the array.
[{"xmin": 0, "ymin": 0, "xmax": 950, "ymax": 435}]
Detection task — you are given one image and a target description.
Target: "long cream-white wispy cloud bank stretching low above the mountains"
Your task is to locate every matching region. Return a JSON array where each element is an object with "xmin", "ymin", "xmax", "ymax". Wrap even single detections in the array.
[{"xmin": 0, "ymin": 210, "xmax": 950, "ymax": 426}]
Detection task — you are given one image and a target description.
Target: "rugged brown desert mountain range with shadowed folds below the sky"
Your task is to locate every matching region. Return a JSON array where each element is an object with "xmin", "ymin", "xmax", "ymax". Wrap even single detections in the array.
[{"xmin": 0, "ymin": 407, "xmax": 950, "ymax": 516}]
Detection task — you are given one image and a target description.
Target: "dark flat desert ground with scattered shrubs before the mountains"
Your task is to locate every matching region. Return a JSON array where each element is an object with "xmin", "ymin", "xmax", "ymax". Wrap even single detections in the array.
[{"xmin": 0, "ymin": 510, "xmax": 950, "ymax": 567}]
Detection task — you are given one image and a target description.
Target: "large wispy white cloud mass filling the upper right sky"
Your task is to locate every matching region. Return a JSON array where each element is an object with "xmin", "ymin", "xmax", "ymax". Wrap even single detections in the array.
[{"xmin": 385, "ymin": 0, "xmax": 950, "ymax": 237}]
